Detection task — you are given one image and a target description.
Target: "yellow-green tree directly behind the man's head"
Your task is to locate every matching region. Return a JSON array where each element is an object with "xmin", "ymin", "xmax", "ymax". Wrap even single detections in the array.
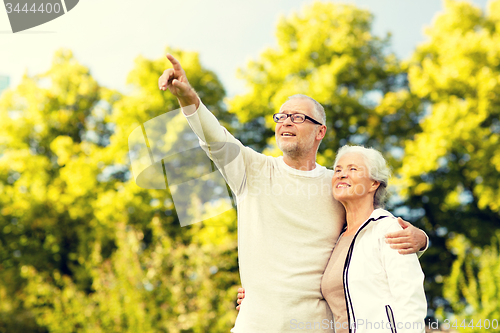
[{"xmin": 229, "ymin": 2, "xmax": 422, "ymax": 166}]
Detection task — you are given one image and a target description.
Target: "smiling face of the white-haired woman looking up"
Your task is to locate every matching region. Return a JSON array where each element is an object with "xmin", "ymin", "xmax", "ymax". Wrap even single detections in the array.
[{"xmin": 332, "ymin": 153, "xmax": 379, "ymax": 202}]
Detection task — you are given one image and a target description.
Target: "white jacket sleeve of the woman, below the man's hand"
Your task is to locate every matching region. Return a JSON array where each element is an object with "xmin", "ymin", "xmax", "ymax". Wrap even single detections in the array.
[{"xmin": 379, "ymin": 217, "xmax": 427, "ymax": 333}]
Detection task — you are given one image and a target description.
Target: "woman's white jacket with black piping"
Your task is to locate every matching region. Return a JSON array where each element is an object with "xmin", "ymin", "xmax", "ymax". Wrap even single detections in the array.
[{"xmin": 343, "ymin": 209, "xmax": 427, "ymax": 333}]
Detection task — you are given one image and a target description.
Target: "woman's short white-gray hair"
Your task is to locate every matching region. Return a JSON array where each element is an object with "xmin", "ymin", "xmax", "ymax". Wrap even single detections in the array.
[{"xmin": 333, "ymin": 145, "xmax": 391, "ymax": 208}]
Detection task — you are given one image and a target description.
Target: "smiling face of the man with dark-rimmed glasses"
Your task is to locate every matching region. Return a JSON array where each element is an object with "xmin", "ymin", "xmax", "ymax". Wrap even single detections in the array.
[{"xmin": 274, "ymin": 99, "xmax": 319, "ymax": 157}]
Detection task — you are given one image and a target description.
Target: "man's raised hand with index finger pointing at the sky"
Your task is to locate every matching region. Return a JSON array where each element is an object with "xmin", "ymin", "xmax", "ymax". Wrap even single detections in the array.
[{"xmin": 158, "ymin": 54, "xmax": 200, "ymax": 110}]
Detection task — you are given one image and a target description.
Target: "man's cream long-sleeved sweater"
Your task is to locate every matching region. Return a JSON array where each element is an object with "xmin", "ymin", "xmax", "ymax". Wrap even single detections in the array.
[{"xmin": 187, "ymin": 103, "xmax": 344, "ymax": 333}]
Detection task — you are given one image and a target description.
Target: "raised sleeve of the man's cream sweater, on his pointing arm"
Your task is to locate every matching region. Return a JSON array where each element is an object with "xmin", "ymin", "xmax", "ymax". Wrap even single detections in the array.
[{"xmin": 186, "ymin": 102, "xmax": 264, "ymax": 196}]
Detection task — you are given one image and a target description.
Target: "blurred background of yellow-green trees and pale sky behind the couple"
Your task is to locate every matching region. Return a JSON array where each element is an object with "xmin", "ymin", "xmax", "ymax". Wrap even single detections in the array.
[{"xmin": 0, "ymin": 0, "xmax": 500, "ymax": 333}]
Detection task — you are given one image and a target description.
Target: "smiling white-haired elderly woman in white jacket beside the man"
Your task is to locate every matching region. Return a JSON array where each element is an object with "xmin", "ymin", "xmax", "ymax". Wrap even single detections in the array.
[{"xmin": 321, "ymin": 146, "xmax": 427, "ymax": 333}]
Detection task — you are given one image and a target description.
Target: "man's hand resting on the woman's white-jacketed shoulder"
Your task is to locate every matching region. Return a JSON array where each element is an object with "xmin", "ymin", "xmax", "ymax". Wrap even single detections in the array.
[{"xmin": 385, "ymin": 217, "xmax": 427, "ymax": 254}]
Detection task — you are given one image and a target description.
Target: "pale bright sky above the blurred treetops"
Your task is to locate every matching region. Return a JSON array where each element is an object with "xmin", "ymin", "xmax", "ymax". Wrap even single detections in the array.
[{"xmin": 0, "ymin": 0, "xmax": 487, "ymax": 97}]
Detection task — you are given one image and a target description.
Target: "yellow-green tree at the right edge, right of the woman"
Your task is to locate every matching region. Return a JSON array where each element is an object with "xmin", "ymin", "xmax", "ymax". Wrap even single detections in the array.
[{"xmin": 399, "ymin": 0, "xmax": 500, "ymax": 307}]
